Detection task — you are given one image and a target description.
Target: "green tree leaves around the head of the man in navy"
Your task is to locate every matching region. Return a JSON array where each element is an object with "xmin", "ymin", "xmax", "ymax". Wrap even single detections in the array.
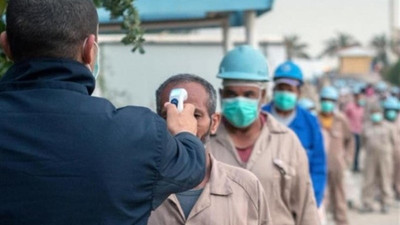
[{"xmin": 0, "ymin": 0, "xmax": 145, "ymax": 77}]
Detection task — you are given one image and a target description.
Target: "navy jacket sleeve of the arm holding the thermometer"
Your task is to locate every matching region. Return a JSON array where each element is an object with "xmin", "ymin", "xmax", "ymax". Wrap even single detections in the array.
[{"xmin": 153, "ymin": 116, "xmax": 206, "ymax": 209}]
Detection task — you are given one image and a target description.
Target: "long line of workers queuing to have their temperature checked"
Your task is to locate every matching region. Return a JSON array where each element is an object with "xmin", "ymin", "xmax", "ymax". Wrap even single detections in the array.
[{"xmin": 148, "ymin": 46, "xmax": 400, "ymax": 225}]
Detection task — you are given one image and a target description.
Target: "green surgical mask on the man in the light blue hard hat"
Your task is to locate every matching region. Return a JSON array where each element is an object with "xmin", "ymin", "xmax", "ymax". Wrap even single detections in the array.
[{"xmin": 222, "ymin": 97, "xmax": 259, "ymax": 128}]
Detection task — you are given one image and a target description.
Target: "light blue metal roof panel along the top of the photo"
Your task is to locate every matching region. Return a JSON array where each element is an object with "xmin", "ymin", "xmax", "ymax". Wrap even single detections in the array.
[{"xmin": 98, "ymin": 0, "xmax": 273, "ymax": 25}]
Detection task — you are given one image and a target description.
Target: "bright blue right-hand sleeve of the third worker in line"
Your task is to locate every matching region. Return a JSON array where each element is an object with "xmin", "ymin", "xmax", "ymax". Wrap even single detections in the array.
[{"xmin": 309, "ymin": 118, "xmax": 327, "ymax": 207}]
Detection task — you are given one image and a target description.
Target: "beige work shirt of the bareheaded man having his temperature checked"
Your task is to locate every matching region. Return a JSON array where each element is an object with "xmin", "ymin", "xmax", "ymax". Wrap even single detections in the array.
[{"xmin": 148, "ymin": 157, "xmax": 272, "ymax": 225}]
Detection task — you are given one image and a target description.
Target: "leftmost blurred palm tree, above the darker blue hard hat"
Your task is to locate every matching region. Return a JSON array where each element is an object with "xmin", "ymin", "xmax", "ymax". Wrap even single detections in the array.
[{"xmin": 284, "ymin": 34, "xmax": 310, "ymax": 60}]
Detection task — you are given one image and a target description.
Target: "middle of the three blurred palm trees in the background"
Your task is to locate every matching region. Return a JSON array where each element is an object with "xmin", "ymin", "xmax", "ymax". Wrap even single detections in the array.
[{"xmin": 319, "ymin": 32, "xmax": 360, "ymax": 57}]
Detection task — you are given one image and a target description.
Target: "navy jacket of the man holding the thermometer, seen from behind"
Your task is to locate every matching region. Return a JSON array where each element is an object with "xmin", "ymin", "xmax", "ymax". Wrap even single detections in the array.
[{"xmin": 0, "ymin": 59, "xmax": 205, "ymax": 225}]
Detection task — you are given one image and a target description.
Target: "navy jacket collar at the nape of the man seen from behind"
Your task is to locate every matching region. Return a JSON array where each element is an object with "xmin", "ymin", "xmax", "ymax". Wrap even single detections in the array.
[{"xmin": 0, "ymin": 58, "xmax": 95, "ymax": 94}]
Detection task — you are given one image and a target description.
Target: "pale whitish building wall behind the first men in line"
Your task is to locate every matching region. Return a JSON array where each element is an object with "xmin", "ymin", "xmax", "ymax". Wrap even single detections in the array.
[{"xmin": 96, "ymin": 42, "xmax": 285, "ymax": 110}]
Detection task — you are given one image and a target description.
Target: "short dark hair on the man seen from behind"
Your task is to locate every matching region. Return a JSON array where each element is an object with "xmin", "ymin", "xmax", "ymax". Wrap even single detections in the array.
[{"xmin": 6, "ymin": 0, "xmax": 98, "ymax": 61}]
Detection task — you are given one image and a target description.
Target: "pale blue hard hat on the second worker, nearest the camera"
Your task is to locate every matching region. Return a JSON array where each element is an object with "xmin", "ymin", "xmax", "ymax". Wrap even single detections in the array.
[{"xmin": 217, "ymin": 45, "xmax": 269, "ymax": 82}]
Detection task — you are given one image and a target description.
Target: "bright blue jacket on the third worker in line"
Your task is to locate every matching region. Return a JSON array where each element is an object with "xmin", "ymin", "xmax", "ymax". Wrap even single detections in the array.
[{"xmin": 262, "ymin": 103, "xmax": 327, "ymax": 207}]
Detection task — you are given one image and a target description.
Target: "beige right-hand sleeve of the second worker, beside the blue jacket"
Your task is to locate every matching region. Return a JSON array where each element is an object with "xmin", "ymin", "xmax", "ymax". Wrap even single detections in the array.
[{"xmin": 290, "ymin": 137, "xmax": 320, "ymax": 225}]
